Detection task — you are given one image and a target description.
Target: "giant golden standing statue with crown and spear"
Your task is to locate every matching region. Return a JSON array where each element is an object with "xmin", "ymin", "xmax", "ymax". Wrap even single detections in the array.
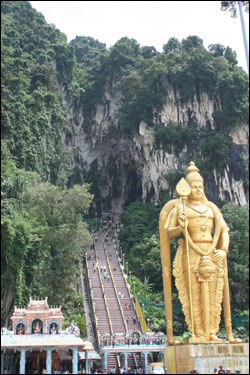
[{"xmin": 159, "ymin": 162, "xmax": 241, "ymax": 345}]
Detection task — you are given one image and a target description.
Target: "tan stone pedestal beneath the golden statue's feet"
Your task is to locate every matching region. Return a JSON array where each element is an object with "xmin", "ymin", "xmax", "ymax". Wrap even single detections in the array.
[{"xmin": 165, "ymin": 343, "xmax": 249, "ymax": 374}]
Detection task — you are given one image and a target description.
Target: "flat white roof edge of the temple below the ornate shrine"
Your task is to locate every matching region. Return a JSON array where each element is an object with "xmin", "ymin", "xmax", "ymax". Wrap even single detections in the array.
[{"xmin": 1, "ymin": 334, "xmax": 84, "ymax": 350}]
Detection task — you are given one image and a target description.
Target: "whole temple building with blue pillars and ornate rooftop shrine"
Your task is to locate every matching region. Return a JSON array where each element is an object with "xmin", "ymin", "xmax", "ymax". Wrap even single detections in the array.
[{"xmin": 1, "ymin": 297, "xmax": 100, "ymax": 374}]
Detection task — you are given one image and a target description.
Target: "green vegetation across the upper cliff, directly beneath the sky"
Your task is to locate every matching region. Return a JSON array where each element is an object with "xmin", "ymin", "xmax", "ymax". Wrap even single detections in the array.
[{"xmin": 1, "ymin": 1, "xmax": 248, "ymax": 186}]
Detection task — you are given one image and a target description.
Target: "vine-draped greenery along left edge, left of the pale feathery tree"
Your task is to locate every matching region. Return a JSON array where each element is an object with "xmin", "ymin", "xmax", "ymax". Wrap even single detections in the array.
[{"xmin": 1, "ymin": 150, "xmax": 40, "ymax": 326}]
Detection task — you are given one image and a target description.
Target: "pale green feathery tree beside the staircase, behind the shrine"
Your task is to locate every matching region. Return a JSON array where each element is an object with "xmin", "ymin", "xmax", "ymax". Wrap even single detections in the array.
[{"xmin": 22, "ymin": 183, "xmax": 93, "ymax": 305}]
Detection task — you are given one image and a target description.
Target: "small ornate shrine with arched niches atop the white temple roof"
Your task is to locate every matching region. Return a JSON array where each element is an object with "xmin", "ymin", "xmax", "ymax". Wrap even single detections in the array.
[{"xmin": 11, "ymin": 297, "xmax": 64, "ymax": 335}]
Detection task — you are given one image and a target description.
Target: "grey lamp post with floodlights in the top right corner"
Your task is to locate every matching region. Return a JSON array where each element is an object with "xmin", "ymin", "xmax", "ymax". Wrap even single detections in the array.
[{"xmin": 220, "ymin": 1, "xmax": 249, "ymax": 74}]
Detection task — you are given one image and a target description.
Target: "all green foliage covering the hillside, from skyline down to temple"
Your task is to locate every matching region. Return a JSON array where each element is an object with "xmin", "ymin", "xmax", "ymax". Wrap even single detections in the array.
[{"xmin": 1, "ymin": 1, "xmax": 248, "ymax": 324}]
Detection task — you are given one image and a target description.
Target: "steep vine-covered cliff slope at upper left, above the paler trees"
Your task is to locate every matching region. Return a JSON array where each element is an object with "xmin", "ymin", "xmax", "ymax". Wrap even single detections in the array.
[{"xmin": 1, "ymin": 1, "xmax": 73, "ymax": 185}]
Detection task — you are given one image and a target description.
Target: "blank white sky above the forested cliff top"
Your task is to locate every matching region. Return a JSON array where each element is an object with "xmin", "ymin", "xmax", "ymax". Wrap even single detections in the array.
[{"xmin": 30, "ymin": 1, "xmax": 249, "ymax": 71}]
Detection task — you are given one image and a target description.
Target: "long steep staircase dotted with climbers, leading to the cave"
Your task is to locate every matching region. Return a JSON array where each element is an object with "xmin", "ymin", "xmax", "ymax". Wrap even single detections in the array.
[{"xmin": 86, "ymin": 229, "xmax": 141, "ymax": 369}]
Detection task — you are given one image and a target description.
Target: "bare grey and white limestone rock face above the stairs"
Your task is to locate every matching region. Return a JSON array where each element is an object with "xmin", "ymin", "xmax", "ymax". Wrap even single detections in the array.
[{"xmin": 65, "ymin": 86, "xmax": 248, "ymax": 211}]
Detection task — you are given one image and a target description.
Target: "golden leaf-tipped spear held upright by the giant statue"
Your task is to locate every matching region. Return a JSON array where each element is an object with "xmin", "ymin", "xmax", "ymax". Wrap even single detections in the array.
[{"xmin": 176, "ymin": 177, "xmax": 195, "ymax": 336}]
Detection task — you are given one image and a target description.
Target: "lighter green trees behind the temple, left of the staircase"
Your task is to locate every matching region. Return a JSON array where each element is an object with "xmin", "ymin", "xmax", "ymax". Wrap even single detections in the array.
[{"xmin": 1, "ymin": 144, "xmax": 93, "ymax": 326}]
